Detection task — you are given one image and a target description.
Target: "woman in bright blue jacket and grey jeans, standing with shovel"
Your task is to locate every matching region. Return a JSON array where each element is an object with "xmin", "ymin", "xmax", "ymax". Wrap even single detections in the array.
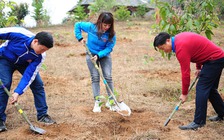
[{"xmin": 74, "ymin": 12, "xmax": 116, "ymax": 112}]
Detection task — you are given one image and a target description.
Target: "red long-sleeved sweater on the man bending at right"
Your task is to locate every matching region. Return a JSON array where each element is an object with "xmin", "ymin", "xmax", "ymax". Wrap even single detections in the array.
[{"xmin": 174, "ymin": 32, "xmax": 224, "ymax": 95}]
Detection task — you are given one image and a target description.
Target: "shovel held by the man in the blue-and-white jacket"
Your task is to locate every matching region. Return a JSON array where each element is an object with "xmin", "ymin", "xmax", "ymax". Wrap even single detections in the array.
[{"xmin": 0, "ymin": 79, "xmax": 46, "ymax": 135}]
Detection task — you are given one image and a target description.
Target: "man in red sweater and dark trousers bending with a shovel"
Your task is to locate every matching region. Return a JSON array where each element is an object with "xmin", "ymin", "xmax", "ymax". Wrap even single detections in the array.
[{"xmin": 153, "ymin": 32, "xmax": 224, "ymax": 130}]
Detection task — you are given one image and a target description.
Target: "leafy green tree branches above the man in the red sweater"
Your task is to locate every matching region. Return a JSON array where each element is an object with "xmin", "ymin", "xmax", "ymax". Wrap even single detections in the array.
[{"xmin": 153, "ymin": 0, "xmax": 219, "ymax": 58}]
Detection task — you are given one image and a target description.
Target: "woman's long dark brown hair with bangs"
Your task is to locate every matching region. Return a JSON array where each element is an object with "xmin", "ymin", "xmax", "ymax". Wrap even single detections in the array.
[{"xmin": 95, "ymin": 12, "xmax": 115, "ymax": 41}]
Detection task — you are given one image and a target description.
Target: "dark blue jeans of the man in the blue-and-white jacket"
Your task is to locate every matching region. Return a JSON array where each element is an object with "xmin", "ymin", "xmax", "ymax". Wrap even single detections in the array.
[{"xmin": 0, "ymin": 58, "xmax": 48, "ymax": 121}]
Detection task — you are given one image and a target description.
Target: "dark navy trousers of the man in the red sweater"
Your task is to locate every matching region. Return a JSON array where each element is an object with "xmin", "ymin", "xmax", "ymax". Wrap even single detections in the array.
[{"xmin": 194, "ymin": 58, "xmax": 224, "ymax": 124}]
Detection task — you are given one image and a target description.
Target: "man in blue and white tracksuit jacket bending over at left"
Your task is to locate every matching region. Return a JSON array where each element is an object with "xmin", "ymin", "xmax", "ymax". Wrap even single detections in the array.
[{"xmin": 0, "ymin": 27, "xmax": 55, "ymax": 132}]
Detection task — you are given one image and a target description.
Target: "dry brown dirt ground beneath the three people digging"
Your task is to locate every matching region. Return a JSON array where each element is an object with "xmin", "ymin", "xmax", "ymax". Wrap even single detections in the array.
[{"xmin": 0, "ymin": 21, "xmax": 224, "ymax": 140}]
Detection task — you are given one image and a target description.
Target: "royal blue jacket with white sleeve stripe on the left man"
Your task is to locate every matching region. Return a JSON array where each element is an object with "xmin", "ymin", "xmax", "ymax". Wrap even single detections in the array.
[{"xmin": 0, "ymin": 27, "xmax": 46, "ymax": 95}]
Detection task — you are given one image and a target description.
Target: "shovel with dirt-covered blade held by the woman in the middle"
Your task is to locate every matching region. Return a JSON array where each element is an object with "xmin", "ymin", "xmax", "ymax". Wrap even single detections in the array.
[{"xmin": 84, "ymin": 42, "xmax": 131, "ymax": 116}]
